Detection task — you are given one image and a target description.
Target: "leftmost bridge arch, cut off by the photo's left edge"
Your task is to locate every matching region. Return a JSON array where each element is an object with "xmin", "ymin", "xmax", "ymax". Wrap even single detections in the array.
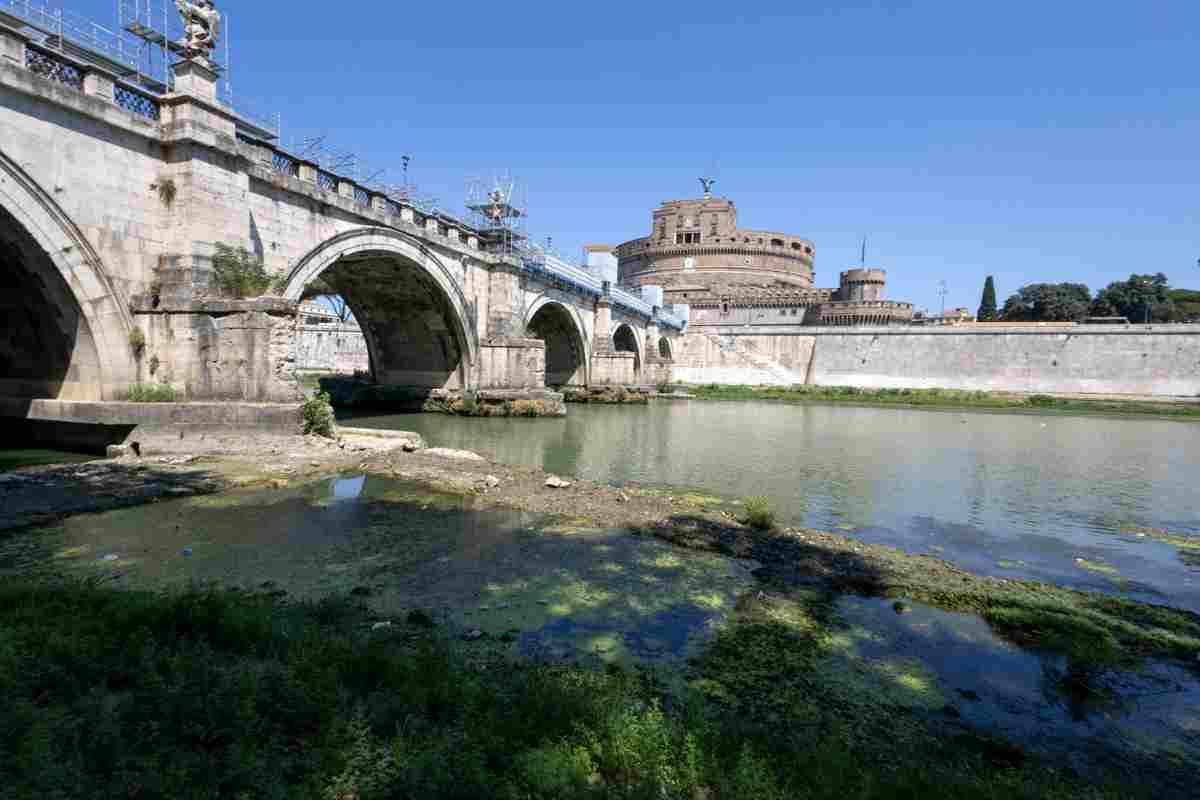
[{"xmin": 0, "ymin": 152, "xmax": 136, "ymax": 401}]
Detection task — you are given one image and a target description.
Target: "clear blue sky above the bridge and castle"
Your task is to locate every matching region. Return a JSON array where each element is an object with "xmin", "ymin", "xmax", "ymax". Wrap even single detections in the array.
[{"xmin": 77, "ymin": 0, "xmax": 1200, "ymax": 309}]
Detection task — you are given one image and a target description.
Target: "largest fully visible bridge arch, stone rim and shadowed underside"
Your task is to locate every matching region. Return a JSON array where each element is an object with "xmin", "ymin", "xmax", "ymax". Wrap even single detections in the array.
[{"xmin": 283, "ymin": 228, "xmax": 479, "ymax": 390}]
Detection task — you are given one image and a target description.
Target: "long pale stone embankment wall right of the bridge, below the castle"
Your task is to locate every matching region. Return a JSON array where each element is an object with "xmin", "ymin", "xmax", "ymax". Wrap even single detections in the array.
[{"xmin": 674, "ymin": 325, "xmax": 1200, "ymax": 397}]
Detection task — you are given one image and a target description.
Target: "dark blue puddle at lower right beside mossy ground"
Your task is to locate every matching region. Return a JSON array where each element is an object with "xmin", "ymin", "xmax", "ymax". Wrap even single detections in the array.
[{"xmin": 824, "ymin": 597, "xmax": 1200, "ymax": 771}]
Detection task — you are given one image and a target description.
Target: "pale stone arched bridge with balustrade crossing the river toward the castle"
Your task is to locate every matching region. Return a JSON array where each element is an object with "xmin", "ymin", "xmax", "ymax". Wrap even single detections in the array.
[{"xmin": 0, "ymin": 28, "xmax": 683, "ymax": 419}]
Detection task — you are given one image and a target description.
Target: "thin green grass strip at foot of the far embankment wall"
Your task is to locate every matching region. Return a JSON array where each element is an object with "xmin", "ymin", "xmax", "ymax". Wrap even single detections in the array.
[{"xmin": 688, "ymin": 384, "xmax": 1200, "ymax": 420}]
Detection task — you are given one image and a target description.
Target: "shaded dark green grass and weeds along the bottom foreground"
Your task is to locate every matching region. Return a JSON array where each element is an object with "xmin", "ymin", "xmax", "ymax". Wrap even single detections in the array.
[{"xmin": 0, "ymin": 584, "xmax": 1130, "ymax": 800}]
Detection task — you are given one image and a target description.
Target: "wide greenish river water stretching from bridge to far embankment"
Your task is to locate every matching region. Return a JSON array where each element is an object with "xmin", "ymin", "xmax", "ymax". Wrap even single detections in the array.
[{"xmin": 343, "ymin": 402, "xmax": 1200, "ymax": 610}]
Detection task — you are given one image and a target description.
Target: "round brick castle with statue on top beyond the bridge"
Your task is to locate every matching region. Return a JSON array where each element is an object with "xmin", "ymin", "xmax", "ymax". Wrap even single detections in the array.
[{"xmin": 604, "ymin": 180, "xmax": 913, "ymax": 326}]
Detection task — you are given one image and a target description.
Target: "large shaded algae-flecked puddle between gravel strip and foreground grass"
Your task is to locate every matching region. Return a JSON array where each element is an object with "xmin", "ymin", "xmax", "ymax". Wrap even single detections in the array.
[{"xmin": 0, "ymin": 475, "xmax": 752, "ymax": 661}]
